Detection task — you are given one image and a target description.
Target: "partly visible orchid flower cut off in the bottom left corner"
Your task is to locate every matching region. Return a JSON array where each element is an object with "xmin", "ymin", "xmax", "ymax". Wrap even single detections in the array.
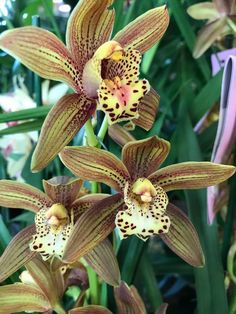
[{"xmin": 0, "ymin": 256, "xmax": 66, "ymax": 314}]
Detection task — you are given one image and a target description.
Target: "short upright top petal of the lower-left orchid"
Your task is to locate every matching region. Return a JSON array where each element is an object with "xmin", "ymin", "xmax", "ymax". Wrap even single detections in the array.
[{"xmin": 43, "ymin": 176, "xmax": 83, "ymax": 208}]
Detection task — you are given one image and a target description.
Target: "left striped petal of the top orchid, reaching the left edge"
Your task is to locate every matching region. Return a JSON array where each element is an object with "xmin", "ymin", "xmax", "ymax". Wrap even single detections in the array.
[{"xmin": 0, "ymin": 26, "xmax": 81, "ymax": 91}]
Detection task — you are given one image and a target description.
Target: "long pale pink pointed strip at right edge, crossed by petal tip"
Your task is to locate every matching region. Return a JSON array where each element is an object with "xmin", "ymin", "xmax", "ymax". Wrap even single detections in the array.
[{"xmin": 207, "ymin": 56, "xmax": 236, "ymax": 223}]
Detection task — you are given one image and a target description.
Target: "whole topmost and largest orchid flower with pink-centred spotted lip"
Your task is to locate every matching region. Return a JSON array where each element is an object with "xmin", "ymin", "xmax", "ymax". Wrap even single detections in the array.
[{"xmin": 0, "ymin": 0, "xmax": 169, "ymax": 171}]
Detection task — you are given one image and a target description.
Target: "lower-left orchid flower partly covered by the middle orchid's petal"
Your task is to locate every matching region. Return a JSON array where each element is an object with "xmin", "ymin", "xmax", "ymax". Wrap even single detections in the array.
[{"xmin": 0, "ymin": 177, "xmax": 120, "ymax": 285}]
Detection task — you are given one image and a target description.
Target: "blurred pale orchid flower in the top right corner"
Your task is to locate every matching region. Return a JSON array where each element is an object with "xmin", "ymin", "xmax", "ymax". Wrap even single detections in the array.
[{"xmin": 187, "ymin": 0, "xmax": 236, "ymax": 58}]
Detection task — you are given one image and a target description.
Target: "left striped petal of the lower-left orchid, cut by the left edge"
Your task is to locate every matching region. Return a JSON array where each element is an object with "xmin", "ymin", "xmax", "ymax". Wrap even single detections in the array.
[{"xmin": 0, "ymin": 180, "xmax": 53, "ymax": 213}]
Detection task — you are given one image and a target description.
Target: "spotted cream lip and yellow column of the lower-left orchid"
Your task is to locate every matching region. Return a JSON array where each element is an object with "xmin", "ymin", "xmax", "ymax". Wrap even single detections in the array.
[{"xmin": 30, "ymin": 204, "xmax": 74, "ymax": 260}]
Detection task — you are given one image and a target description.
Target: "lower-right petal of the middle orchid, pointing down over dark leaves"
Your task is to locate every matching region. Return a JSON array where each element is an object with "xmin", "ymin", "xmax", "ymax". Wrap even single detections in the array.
[{"xmin": 160, "ymin": 204, "xmax": 205, "ymax": 267}]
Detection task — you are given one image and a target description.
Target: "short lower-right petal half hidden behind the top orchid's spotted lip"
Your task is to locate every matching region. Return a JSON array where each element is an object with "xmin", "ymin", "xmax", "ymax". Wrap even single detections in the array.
[{"xmin": 132, "ymin": 88, "xmax": 160, "ymax": 131}]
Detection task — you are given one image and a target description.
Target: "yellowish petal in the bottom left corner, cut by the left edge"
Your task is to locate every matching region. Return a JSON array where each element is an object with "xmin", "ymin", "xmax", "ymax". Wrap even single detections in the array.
[{"xmin": 0, "ymin": 283, "xmax": 51, "ymax": 314}]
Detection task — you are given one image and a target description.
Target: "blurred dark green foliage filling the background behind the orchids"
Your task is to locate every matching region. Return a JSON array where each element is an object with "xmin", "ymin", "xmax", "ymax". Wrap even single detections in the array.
[{"xmin": 0, "ymin": 0, "xmax": 236, "ymax": 314}]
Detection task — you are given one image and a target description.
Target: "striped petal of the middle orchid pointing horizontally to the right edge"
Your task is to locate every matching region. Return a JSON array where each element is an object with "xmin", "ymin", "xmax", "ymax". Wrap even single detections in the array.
[{"xmin": 148, "ymin": 162, "xmax": 235, "ymax": 191}]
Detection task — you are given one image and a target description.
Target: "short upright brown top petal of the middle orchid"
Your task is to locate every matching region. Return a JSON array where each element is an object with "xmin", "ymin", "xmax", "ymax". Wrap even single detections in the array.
[{"xmin": 122, "ymin": 136, "xmax": 170, "ymax": 179}]
